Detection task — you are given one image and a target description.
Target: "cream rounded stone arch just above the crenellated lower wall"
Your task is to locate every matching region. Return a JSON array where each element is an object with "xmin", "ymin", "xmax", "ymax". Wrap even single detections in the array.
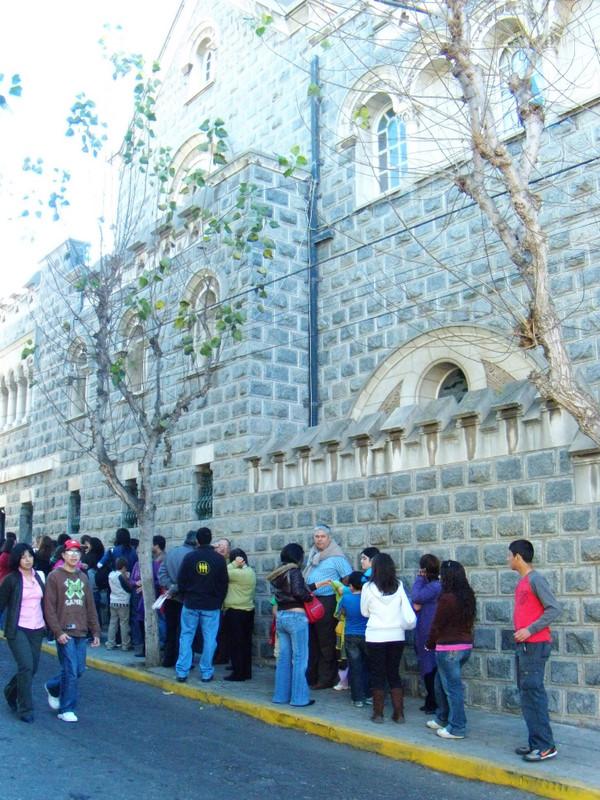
[{"xmin": 351, "ymin": 325, "xmax": 539, "ymax": 419}]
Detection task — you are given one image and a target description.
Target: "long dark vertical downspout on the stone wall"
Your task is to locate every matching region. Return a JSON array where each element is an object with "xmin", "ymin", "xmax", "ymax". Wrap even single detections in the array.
[{"xmin": 308, "ymin": 56, "xmax": 321, "ymax": 427}]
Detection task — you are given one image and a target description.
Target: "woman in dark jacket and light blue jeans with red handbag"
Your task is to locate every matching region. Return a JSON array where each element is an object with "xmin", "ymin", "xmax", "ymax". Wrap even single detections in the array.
[{"xmin": 267, "ymin": 543, "xmax": 315, "ymax": 706}]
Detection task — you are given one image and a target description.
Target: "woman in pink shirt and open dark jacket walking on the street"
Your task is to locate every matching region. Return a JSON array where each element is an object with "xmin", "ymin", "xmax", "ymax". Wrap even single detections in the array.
[{"xmin": 0, "ymin": 543, "xmax": 46, "ymax": 722}]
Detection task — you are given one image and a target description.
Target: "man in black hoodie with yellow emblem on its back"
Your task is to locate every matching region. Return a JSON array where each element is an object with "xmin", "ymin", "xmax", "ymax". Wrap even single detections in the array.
[{"xmin": 175, "ymin": 528, "xmax": 229, "ymax": 683}]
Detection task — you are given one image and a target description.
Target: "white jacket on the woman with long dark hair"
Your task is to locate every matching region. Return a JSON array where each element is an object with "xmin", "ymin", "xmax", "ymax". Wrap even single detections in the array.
[{"xmin": 360, "ymin": 581, "xmax": 417, "ymax": 642}]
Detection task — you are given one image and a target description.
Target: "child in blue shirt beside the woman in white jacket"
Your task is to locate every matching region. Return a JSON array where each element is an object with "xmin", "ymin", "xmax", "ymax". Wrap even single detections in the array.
[{"xmin": 338, "ymin": 572, "xmax": 369, "ymax": 708}]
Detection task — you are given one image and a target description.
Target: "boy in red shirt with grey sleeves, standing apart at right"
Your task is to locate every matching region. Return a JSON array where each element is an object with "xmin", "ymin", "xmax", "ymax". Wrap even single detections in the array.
[{"xmin": 508, "ymin": 539, "xmax": 562, "ymax": 762}]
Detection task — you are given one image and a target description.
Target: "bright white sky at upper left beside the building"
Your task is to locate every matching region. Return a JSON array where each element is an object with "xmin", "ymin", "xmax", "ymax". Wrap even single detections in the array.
[{"xmin": 0, "ymin": 0, "xmax": 180, "ymax": 298}]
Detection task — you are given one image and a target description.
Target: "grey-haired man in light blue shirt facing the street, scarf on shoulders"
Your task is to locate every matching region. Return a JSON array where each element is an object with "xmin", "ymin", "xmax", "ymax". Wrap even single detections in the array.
[{"xmin": 304, "ymin": 524, "xmax": 352, "ymax": 689}]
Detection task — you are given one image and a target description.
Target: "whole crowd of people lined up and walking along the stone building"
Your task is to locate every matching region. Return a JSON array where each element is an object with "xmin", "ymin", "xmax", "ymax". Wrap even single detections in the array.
[{"xmin": 0, "ymin": 524, "xmax": 561, "ymax": 761}]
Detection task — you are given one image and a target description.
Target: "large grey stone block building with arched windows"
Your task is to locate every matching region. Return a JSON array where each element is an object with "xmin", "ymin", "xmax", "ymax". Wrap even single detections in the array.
[{"xmin": 0, "ymin": 0, "xmax": 600, "ymax": 725}]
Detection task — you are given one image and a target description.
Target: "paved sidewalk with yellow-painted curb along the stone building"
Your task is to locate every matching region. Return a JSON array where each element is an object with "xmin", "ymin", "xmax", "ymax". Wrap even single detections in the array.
[{"xmin": 44, "ymin": 645, "xmax": 600, "ymax": 800}]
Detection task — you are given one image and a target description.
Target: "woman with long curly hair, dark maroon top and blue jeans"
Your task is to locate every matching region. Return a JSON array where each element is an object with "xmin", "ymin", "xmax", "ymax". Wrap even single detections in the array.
[{"xmin": 426, "ymin": 561, "xmax": 475, "ymax": 739}]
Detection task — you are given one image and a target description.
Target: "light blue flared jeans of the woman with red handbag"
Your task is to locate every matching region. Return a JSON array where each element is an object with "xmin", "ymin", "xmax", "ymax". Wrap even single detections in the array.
[{"xmin": 273, "ymin": 611, "xmax": 310, "ymax": 706}]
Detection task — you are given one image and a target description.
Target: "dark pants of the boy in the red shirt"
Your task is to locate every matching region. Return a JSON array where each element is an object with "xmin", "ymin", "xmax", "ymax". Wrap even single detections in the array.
[{"xmin": 516, "ymin": 642, "xmax": 554, "ymax": 750}]
